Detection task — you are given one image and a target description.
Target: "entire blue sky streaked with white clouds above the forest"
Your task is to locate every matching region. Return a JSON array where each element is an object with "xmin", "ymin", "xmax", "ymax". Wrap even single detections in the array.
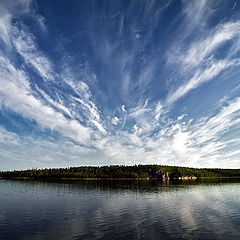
[{"xmin": 0, "ymin": 0, "xmax": 240, "ymax": 170}]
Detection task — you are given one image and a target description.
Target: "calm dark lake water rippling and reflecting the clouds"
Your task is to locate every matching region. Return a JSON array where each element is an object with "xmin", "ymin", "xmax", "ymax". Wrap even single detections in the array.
[{"xmin": 0, "ymin": 180, "xmax": 240, "ymax": 240}]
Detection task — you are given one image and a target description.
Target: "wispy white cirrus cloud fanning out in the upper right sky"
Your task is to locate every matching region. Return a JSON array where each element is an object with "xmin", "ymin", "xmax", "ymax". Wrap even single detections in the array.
[{"xmin": 166, "ymin": 1, "xmax": 240, "ymax": 105}]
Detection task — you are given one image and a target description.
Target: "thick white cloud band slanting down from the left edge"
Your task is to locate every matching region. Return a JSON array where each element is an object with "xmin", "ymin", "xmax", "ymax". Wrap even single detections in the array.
[{"xmin": 0, "ymin": 54, "xmax": 90, "ymax": 142}]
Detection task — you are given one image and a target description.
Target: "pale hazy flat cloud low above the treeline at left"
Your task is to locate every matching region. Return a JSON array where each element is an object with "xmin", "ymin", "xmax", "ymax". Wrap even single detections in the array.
[{"xmin": 0, "ymin": 127, "xmax": 101, "ymax": 170}]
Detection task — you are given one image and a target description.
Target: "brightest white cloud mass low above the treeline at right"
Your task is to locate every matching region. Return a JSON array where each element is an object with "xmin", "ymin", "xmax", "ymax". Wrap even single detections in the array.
[{"xmin": 96, "ymin": 95, "xmax": 240, "ymax": 167}]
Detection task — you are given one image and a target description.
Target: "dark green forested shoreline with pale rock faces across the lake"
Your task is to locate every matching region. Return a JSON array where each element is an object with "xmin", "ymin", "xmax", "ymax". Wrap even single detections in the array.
[{"xmin": 0, "ymin": 165, "xmax": 240, "ymax": 179}]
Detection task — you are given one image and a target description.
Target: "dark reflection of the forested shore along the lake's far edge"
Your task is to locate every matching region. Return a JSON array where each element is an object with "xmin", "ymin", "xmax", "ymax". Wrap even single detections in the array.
[{"xmin": 2, "ymin": 178, "xmax": 240, "ymax": 193}]
